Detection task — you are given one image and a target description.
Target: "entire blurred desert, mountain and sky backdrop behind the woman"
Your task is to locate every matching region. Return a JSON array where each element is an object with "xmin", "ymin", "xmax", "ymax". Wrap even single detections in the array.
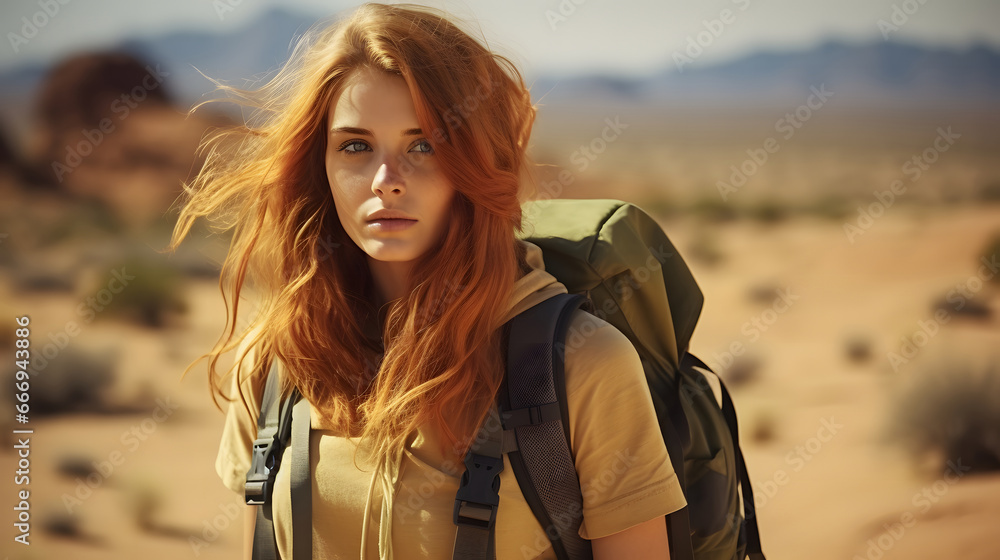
[{"xmin": 0, "ymin": 0, "xmax": 1000, "ymax": 560}]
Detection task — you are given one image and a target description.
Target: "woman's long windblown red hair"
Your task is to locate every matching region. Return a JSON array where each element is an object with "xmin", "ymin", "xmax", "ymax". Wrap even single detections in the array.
[{"xmin": 169, "ymin": 4, "xmax": 535, "ymax": 468}]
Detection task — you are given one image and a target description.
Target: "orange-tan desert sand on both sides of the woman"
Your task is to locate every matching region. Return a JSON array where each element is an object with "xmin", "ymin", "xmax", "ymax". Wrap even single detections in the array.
[{"xmin": 0, "ymin": 199, "xmax": 1000, "ymax": 560}]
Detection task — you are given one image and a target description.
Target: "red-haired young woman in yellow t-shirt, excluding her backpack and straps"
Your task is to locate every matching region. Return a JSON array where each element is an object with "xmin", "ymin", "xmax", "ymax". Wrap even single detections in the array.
[{"xmin": 172, "ymin": 4, "xmax": 685, "ymax": 560}]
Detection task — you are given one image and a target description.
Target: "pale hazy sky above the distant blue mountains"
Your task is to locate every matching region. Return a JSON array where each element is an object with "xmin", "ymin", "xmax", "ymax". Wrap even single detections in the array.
[{"xmin": 0, "ymin": 0, "xmax": 1000, "ymax": 74}]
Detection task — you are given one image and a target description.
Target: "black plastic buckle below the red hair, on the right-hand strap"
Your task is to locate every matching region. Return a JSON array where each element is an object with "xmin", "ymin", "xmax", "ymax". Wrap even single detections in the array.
[{"xmin": 452, "ymin": 452, "xmax": 503, "ymax": 529}]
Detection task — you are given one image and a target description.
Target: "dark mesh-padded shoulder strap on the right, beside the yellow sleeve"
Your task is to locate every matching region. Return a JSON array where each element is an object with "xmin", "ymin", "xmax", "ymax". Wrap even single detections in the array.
[{"xmin": 453, "ymin": 294, "xmax": 592, "ymax": 560}]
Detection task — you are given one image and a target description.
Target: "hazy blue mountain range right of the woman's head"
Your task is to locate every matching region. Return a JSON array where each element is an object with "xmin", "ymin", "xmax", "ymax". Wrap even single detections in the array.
[{"xmin": 538, "ymin": 40, "xmax": 1000, "ymax": 107}]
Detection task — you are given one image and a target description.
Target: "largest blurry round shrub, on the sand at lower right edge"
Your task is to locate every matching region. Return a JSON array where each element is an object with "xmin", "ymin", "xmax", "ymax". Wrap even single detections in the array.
[{"xmin": 886, "ymin": 356, "xmax": 1000, "ymax": 472}]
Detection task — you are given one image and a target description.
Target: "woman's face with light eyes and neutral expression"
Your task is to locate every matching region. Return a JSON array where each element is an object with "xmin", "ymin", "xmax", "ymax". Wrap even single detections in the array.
[{"xmin": 326, "ymin": 71, "xmax": 454, "ymax": 270}]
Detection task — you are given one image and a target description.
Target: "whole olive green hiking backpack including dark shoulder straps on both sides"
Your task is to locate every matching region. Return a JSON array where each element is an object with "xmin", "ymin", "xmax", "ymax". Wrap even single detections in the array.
[{"xmin": 247, "ymin": 200, "xmax": 765, "ymax": 560}]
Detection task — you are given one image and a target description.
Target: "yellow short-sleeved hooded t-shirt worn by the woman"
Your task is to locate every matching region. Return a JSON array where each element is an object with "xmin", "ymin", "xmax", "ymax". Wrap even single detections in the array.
[{"xmin": 215, "ymin": 241, "xmax": 686, "ymax": 560}]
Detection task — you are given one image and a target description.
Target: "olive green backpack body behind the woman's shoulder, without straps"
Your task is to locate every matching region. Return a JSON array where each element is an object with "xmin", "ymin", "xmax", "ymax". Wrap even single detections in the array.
[{"xmin": 490, "ymin": 200, "xmax": 764, "ymax": 560}]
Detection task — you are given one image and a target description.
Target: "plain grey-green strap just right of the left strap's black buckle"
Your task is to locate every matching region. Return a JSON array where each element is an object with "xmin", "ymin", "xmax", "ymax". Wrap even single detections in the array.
[{"xmin": 289, "ymin": 399, "xmax": 312, "ymax": 560}]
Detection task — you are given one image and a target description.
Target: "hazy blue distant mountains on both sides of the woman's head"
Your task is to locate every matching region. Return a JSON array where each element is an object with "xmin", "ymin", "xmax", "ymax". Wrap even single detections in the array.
[{"xmin": 0, "ymin": 10, "xmax": 1000, "ymax": 138}]
